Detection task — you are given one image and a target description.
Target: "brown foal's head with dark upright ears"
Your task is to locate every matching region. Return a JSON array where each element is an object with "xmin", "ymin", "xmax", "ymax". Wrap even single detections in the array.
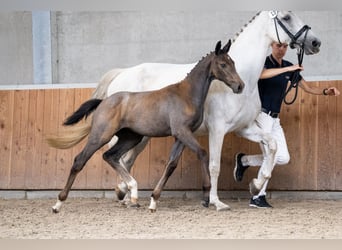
[{"xmin": 210, "ymin": 40, "xmax": 245, "ymax": 93}]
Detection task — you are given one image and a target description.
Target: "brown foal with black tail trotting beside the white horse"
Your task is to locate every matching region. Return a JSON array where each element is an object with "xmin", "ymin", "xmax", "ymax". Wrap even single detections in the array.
[{"xmin": 48, "ymin": 40, "xmax": 244, "ymax": 213}]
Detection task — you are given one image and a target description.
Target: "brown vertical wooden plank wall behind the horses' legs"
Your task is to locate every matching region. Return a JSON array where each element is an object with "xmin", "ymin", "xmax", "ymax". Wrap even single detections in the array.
[{"xmin": 0, "ymin": 81, "xmax": 342, "ymax": 191}]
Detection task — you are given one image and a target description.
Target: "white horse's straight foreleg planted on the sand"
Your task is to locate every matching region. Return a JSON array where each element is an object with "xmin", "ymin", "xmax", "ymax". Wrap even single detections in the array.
[{"xmin": 209, "ymin": 130, "xmax": 230, "ymax": 211}]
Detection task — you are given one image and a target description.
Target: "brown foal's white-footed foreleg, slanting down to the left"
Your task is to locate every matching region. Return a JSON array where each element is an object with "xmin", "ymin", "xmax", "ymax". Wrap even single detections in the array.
[{"xmin": 149, "ymin": 140, "xmax": 185, "ymax": 212}]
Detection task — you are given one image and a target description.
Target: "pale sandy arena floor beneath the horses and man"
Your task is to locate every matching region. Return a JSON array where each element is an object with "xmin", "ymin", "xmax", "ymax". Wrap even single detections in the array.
[{"xmin": 0, "ymin": 197, "xmax": 342, "ymax": 239}]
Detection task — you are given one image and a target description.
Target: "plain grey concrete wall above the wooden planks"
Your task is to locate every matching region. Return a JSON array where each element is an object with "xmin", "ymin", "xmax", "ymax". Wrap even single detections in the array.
[{"xmin": 0, "ymin": 11, "xmax": 342, "ymax": 85}]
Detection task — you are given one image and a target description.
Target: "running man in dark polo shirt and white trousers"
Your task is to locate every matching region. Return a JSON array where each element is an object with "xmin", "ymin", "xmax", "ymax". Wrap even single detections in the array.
[{"xmin": 234, "ymin": 42, "xmax": 340, "ymax": 208}]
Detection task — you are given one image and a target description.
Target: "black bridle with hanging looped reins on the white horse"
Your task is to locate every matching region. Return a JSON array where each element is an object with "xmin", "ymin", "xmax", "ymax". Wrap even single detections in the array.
[{"xmin": 269, "ymin": 11, "xmax": 311, "ymax": 105}]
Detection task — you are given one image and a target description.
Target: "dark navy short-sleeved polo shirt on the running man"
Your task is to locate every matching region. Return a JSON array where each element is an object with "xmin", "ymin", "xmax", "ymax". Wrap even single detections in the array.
[{"xmin": 258, "ymin": 54, "xmax": 302, "ymax": 113}]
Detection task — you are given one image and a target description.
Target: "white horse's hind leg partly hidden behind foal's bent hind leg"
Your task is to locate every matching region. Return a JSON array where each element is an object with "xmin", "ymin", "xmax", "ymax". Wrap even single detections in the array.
[{"xmin": 115, "ymin": 136, "xmax": 150, "ymax": 201}]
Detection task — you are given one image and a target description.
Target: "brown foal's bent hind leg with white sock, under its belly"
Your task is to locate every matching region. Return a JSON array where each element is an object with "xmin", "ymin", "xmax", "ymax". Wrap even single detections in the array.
[{"xmin": 103, "ymin": 129, "xmax": 143, "ymax": 206}]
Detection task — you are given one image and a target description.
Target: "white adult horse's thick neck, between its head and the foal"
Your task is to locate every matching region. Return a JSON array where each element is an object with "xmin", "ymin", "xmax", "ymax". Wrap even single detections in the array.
[{"xmin": 229, "ymin": 13, "xmax": 271, "ymax": 95}]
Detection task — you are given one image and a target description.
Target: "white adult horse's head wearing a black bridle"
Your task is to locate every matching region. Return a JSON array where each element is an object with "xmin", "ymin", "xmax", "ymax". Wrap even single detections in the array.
[{"xmin": 268, "ymin": 11, "xmax": 321, "ymax": 55}]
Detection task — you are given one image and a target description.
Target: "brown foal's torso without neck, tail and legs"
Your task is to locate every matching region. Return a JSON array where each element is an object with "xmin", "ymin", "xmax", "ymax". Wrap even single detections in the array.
[{"xmin": 94, "ymin": 80, "xmax": 198, "ymax": 137}]
